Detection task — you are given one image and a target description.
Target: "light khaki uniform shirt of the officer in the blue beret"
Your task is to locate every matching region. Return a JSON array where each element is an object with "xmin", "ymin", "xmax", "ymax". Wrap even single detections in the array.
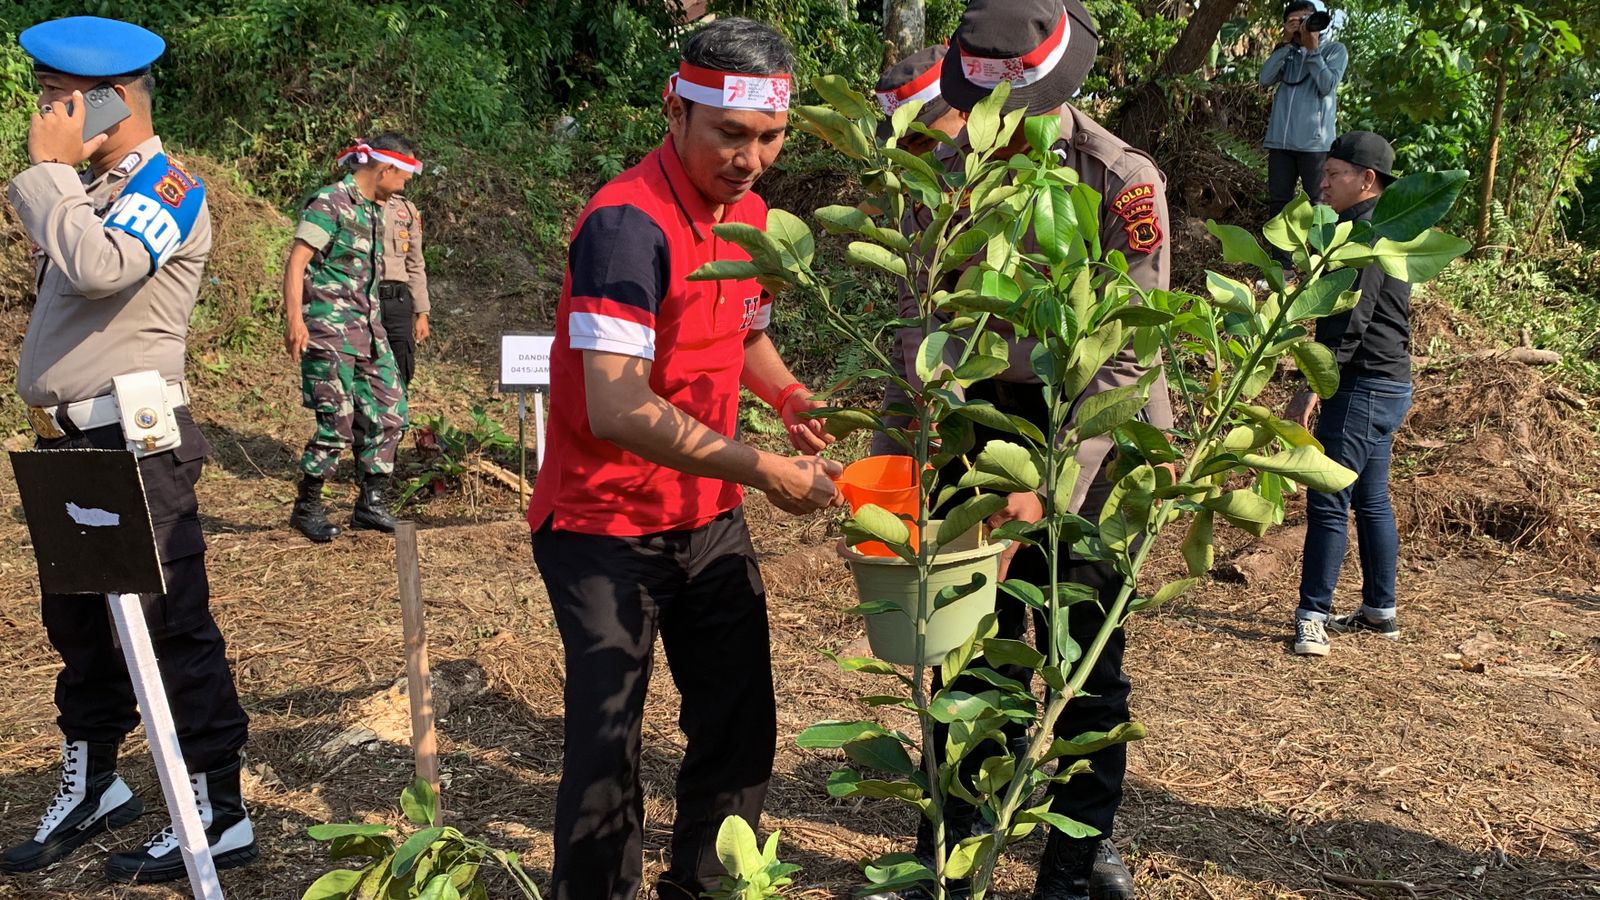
[{"xmin": 6, "ymin": 136, "xmax": 211, "ymax": 407}]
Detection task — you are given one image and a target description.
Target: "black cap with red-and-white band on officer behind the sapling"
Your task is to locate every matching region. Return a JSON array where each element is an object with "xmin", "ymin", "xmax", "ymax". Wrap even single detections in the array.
[{"xmin": 941, "ymin": 0, "xmax": 1099, "ymax": 115}]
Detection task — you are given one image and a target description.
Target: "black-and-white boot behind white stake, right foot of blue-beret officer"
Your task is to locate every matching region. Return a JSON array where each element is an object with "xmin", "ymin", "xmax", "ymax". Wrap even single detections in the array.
[{"xmin": 106, "ymin": 761, "xmax": 261, "ymax": 884}]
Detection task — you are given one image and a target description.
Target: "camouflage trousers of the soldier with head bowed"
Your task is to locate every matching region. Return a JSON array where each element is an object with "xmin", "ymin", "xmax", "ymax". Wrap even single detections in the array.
[{"xmin": 301, "ymin": 346, "xmax": 408, "ymax": 479}]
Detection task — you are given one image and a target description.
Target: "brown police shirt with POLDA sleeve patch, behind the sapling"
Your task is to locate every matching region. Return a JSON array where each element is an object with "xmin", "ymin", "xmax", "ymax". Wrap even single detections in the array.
[{"xmin": 874, "ymin": 106, "xmax": 1173, "ymax": 509}]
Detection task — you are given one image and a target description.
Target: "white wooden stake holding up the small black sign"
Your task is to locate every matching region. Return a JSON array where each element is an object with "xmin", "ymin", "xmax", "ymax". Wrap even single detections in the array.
[{"xmin": 106, "ymin": 594, "xmax": 222, "ymax": 900}]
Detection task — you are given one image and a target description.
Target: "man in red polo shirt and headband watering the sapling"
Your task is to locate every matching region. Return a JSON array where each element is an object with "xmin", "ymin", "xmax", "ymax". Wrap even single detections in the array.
[{"xmin": 528, "ymin": 18, "xmax": 842, "ymax": 900}]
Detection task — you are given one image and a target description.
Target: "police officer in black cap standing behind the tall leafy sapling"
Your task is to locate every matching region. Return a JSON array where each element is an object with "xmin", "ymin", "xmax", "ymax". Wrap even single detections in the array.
[{"xmin": 875, "ymin": 0, "xmax": 1171, "ymax": 900}]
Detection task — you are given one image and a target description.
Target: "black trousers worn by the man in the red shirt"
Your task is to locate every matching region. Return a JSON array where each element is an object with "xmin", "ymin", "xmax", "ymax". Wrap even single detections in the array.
[{"xmin": 533, "ymin": 509, "xmax": 778, "ymax": 900}]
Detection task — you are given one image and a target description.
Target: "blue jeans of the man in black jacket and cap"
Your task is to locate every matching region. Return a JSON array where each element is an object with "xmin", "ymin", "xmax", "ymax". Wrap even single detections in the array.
[{"xmin": 1294, "ymin": 376, "xmax": 1411, "ymax": 621}]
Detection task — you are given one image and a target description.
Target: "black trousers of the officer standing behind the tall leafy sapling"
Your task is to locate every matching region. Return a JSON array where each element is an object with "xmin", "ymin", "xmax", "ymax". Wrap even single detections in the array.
[{"xmin": 934, "ymin": 381, "xmax": 1133, "ymax": 838}]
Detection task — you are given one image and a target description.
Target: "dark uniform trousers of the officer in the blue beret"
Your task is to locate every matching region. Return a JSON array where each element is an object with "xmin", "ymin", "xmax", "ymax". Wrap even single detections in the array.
[{"xmin": 37, "ymin": 407, "xmax": 250, "ymax": 762}]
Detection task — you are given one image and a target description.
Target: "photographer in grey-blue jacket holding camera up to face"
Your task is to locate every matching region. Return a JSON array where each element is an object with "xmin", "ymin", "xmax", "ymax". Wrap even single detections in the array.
[{"xmin": 1261, "ymin": 0, "xmax": 1350, "ymax": 269}]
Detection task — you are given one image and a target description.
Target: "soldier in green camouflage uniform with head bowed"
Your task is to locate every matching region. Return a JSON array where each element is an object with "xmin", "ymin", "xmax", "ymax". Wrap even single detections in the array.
[{"xmin": 283, "ymin": 135, "xmax": 421, "ymax": 543}]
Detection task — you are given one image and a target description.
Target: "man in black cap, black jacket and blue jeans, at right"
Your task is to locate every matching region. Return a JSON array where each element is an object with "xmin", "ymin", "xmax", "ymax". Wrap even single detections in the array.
[{"xmin": 1285, "ymin": 131, "xmax": 1411, "ymax": 657}]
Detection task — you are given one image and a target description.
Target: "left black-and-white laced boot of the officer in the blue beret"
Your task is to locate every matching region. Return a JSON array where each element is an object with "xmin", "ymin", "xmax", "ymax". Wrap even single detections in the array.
[{"xmin": 0, "ymin": 740, "xmax": 144, "ymax": 873}]
